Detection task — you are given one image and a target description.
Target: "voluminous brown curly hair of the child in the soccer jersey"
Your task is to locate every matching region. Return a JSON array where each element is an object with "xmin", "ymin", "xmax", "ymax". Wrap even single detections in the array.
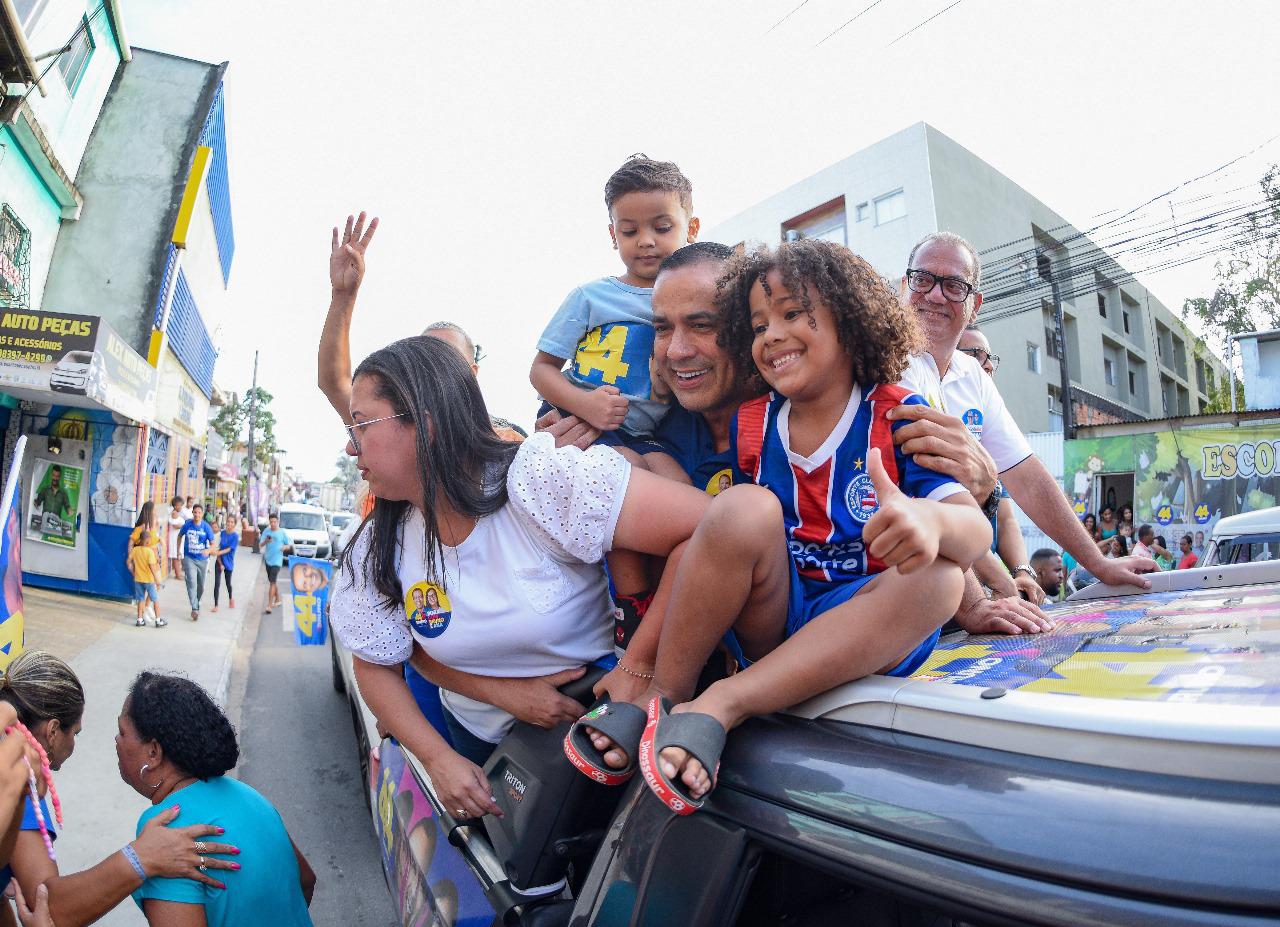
[{"xmin": 716, "ymin": 238, "xmax": 924, "ymax": 392}]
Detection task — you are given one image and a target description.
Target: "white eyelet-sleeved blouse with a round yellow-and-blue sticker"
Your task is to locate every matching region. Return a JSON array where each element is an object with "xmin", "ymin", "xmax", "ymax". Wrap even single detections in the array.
[{"xmin": 330, "ymin": 434, "xmax": 631, "ymax": 743}]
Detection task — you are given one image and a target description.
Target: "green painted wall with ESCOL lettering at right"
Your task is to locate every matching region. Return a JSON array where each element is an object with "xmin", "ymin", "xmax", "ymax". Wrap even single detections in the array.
[{"xmin": 1064, "ymin": 424, "xmax": 1280, "ymax": 540}]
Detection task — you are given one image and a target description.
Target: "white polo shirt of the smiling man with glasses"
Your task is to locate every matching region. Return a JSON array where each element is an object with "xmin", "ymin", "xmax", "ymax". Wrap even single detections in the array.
[{"xmin": 899, "ymin": 351, "xmax": 1032, "ymax": 472}]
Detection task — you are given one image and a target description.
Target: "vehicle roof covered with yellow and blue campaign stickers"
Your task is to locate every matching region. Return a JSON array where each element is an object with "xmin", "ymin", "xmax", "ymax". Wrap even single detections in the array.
[{"xmin": 791, "ymin": 562, "xmax": 1280, "ymax": 785}]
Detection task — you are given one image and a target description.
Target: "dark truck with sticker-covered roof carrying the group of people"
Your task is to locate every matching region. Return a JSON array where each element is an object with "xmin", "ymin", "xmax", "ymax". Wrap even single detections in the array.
[{"xmin": 333, "ymin": 563, "xmax": 1280, "ymax": 927}]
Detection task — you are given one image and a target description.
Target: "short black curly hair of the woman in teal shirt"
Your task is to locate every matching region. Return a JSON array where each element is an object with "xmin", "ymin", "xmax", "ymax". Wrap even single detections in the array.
[{"xmin": 128, "ymin": 671, "xmax": 239, "ymax": 778}]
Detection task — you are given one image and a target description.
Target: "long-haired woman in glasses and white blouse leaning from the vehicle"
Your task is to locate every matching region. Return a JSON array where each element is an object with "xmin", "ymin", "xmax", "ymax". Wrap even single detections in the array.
[{"xmin": 332, "ymin": 337, "xmax": 708, "ymax": 817}]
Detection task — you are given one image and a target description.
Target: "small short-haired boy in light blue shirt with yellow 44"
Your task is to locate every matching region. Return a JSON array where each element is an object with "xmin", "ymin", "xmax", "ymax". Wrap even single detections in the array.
[{"xmin": 529, "ymin": 155, "xmax": 699, "ymax": 648}]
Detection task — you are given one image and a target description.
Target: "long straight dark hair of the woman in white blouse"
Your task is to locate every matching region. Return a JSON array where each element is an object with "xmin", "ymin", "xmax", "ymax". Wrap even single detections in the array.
[{"xmin": 342, "ymin": 335, "xmax": 520, "ymax": 607}]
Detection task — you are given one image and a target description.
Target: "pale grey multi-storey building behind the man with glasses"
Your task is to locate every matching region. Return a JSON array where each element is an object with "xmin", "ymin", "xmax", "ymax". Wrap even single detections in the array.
[{"xmin": 704, "ymin": 123, "xmax": 1226, "ymax": 431}]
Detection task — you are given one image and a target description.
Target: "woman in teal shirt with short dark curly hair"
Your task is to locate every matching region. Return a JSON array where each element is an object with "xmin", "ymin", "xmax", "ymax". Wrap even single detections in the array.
[{"xmin": 115, "ymin": 672, "xmax": 316, "ymax": 927}]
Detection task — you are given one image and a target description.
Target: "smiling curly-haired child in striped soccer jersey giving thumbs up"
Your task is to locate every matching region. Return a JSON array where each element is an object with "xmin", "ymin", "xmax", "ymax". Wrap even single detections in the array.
[{"xmin": 568, "ymin": 239, "xmax": 991, "ymax": 813}]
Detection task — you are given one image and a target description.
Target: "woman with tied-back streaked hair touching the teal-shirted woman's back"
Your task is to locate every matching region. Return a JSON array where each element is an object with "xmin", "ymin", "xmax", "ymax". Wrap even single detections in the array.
[{"xmin": 0, "ymin": 650, "xmax": 238, "ymax": 927}]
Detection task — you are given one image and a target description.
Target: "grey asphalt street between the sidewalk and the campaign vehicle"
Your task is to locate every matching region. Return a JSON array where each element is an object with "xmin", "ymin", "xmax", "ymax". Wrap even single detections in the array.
[{"xmin": 233, "ymin": 576, "xmax": 399, "ymax": 927}]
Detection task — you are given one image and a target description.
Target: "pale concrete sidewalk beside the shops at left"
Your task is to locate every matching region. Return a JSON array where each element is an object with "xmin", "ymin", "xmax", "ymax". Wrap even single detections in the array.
[{"xmin": 24, "ymin": 548, "xmax": 266, "ymax": 927}]
